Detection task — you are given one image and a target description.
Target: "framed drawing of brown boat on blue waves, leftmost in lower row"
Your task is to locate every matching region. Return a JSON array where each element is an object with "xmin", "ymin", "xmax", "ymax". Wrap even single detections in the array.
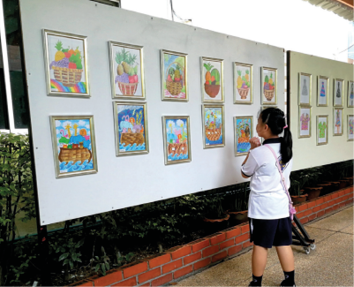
[{"xmin": 50, "ymin": 116, "xmax": 97, "ymax": 178}]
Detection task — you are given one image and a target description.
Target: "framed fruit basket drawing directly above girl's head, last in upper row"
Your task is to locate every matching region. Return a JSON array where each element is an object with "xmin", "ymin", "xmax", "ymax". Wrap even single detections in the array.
[{"xmin": 261, "ymin": 67, "xmax": 278, "ymax": 105}]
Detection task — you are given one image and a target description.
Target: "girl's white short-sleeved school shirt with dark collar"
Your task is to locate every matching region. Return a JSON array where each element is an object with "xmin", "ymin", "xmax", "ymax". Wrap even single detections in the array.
[{"xmin": 241, "ymin": 138, "xmax": 293, "ymax": 219}]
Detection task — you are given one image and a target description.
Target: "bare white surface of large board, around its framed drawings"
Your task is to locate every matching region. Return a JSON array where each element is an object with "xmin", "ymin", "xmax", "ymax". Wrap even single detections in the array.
[{"xmin": 20, "ymin": 0, "xmax": 284, "ymax": 225}]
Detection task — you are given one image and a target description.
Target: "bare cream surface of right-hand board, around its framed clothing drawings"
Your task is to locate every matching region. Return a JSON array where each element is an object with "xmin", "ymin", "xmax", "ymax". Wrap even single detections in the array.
[{"xmin": 288, "ymin": 52, "xmax": 354, "ymax": 170}]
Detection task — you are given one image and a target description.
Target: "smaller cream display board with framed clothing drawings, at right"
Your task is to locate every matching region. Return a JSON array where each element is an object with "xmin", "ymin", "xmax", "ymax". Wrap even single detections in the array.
[{"xmin": 287, "ymin": 51, "xmax": 354, "ymax": 170}]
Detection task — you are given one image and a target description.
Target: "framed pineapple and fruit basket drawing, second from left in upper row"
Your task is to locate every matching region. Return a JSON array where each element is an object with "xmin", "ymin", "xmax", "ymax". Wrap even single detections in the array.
[{"xmin": 109, "ymin": 42, "xmax": 145, "ymax": 100}]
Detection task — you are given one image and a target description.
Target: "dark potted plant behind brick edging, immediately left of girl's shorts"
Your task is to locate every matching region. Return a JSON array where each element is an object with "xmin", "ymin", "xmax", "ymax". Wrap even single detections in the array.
[{"xmin": 226, "ymin": 182, "xmax": 250, "ymax": 225}]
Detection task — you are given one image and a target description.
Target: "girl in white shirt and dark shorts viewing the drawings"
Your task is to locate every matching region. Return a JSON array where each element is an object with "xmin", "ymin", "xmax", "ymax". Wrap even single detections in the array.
[{"xmin": 241, "ymin": 108, "xmax": 296, "ymax": 287}]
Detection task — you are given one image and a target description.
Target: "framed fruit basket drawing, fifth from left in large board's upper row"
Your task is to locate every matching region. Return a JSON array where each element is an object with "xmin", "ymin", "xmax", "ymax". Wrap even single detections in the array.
[{"xmin": 234, "ymin": 62, "xmax": 253, "ymax": 104}]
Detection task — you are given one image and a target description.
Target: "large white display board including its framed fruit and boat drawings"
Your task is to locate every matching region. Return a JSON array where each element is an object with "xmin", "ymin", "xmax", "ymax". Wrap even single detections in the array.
[{"xmin": 20, "ymin": 0, "xmax": 284, "ymax": 225}]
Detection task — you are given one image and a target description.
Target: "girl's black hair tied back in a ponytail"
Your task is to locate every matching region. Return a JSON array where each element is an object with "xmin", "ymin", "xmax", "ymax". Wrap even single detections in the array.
[{"xmin": 259, "ymin": 108, "xmax": 293, "ymax": 164}]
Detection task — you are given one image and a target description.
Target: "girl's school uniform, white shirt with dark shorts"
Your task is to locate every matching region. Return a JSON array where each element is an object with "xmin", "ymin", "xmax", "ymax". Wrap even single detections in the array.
[{"xmin": 241, "ymin": 138, "xmax": 293, "ymax": 248}]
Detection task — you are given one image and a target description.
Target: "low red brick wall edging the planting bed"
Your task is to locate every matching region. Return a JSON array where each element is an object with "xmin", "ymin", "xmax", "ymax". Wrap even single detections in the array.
[{"xmin": 68, "ymin": 186, "xmax": 354, "ymax": 287}]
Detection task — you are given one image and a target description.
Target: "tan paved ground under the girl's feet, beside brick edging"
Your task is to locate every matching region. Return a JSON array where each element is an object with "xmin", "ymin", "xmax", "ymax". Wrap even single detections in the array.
[{"xmin": 177, "ymin": 206, "xmax": 354, "ymax": 287}]
